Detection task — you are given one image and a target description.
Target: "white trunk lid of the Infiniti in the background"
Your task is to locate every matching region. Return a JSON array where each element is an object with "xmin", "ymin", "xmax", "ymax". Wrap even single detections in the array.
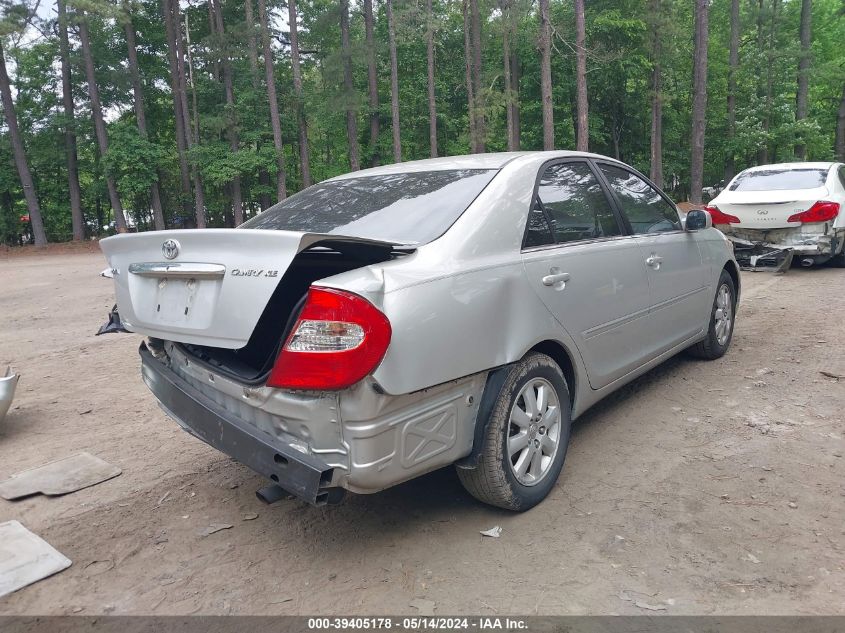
[{"xmin": 712, "ymin": 187, "xmax": 829, "ymax": 230}]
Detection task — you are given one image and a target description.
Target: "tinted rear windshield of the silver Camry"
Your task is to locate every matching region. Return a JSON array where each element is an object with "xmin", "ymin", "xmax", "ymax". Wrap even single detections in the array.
[{"xmin": 241, "ymin": 169, "xmax": 496, "ymax": 244}]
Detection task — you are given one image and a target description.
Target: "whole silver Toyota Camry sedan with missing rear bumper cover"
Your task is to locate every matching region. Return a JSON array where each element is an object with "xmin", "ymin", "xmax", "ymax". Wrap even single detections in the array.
[{"xmin": 101, "ymin": 151, "xmax": 739, "ymax": 510}]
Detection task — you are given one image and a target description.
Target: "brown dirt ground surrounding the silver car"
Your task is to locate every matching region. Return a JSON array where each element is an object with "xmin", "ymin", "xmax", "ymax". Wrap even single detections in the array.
[{"xmin": 0, "ymin": 249, "xmax": 845, "ymax": 615}]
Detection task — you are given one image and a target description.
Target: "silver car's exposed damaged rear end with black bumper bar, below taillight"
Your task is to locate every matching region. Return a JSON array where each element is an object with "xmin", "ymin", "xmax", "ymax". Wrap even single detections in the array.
[{"xmin": 140, "ymin": 339, "xmax": 487, "ymax": 505}]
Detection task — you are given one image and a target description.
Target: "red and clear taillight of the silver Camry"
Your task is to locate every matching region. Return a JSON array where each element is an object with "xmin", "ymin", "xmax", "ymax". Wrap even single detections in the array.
[{"xmin": 267, "ymin": 286, "xmax": 391, "ymax": 391}]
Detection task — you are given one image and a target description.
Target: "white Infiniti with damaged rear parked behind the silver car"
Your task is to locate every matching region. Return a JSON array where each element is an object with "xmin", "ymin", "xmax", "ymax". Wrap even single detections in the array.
[{"xmin": 707, "ymin": 163, "xmax": 845, "ymax": 268}]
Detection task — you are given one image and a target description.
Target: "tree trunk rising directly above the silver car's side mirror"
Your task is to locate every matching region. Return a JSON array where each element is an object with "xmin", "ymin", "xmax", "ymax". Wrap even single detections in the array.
[{"xmin": 690, "ymin": 0, "xmax": 710, "ymax": 204}]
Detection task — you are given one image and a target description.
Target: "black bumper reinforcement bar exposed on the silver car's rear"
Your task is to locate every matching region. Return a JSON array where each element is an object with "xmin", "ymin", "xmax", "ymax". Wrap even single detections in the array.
[{"xmin": 140, "ymin": 344, "xmax": 343, "ymax": 505}]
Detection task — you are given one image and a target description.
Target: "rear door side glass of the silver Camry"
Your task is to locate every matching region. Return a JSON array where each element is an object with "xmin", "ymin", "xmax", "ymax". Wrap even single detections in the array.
[{"xmin": 537, "ymin": 162, "xmax": 621, "ymax": 243}]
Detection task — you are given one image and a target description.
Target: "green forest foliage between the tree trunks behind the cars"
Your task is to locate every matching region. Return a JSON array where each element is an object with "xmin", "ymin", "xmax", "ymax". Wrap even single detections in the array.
[{"xmin": 0, "ymin": 0, "xmax": 845, "ymax": 242}]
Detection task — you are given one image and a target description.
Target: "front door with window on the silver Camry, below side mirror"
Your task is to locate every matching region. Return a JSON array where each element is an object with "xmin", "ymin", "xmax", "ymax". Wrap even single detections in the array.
[{"xmin": 598, "ymin": 162, "xmax": 712, "ymax": 356}]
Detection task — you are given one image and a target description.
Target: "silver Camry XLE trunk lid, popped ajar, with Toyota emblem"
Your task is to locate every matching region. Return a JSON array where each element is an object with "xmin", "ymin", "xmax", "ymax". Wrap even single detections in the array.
[{"xmin": 100, "ymin": 229, "xmax": 402, "ymax": 349}]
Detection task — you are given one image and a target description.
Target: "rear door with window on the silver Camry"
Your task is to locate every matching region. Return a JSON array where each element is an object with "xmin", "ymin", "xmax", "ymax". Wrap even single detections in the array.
[{"xmin": 522, "ymin": 160, "xmax": 649, "ymax": 389}]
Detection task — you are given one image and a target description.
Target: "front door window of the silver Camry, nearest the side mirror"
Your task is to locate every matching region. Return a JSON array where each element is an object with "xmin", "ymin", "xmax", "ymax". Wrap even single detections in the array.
[{"xmin": 601, "ymin": 164, "xmax": 681, "ymax": 235}]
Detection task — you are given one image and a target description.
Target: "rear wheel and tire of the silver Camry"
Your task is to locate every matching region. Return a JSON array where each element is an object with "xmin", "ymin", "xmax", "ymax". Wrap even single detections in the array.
[{"xmin": 457, "ymin": 352, "xmax": 572, "ymax": 511}]
